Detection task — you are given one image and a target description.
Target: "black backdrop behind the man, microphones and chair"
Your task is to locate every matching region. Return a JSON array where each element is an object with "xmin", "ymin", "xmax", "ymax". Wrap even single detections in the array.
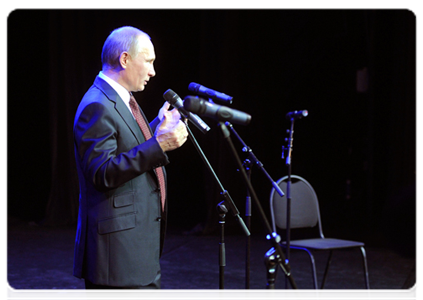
[{"xmin": 5, "ymin": 9, "xmax": 420, "ymax": 253}]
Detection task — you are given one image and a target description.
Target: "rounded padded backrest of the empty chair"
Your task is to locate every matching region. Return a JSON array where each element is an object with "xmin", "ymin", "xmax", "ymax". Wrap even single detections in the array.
[{"xmin": 270, "ymin": 175, "xmax": 324, "ymax": 238}]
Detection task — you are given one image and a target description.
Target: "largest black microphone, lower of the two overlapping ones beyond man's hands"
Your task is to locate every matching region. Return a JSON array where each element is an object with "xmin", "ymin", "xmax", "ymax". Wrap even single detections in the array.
[{"xmin": 184, "ymin": 96, "xmax": 251, "ymax": 125}]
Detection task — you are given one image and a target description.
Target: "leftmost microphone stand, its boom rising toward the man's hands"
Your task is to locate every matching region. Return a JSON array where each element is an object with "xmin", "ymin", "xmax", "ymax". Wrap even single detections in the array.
[{"xmin": 185, "ymin": 123, "xmax": 250, "ymax": 300}]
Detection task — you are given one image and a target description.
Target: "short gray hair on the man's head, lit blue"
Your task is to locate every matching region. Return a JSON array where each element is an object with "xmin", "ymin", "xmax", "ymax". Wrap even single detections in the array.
[{"xmin": 101, "ymin": 26, "xmax": 151, "ymax": 69}]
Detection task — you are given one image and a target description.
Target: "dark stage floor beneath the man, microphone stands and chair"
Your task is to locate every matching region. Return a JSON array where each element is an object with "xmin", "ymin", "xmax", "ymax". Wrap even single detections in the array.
[{"xmin": 5, "ymin": 217, "xmax": 420, "ymax": 300}]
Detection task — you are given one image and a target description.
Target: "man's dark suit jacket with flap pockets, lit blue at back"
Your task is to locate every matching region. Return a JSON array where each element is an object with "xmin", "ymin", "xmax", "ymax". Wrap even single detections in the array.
[{"xmin": 74, "ymin": 77, "xmax": 168, "ymax": 286}]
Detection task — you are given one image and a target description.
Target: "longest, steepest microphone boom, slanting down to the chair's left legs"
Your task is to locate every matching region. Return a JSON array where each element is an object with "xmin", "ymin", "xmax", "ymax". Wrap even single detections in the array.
[{"xmin": 219, "ymin": 122, "xmax": 302, "ymax": 299}]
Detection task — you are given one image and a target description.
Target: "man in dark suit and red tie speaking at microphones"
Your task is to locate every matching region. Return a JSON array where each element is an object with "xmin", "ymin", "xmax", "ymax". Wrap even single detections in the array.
[{"xmin": 74, "ymin": 27, "xmax": 188, "ymax": 300}]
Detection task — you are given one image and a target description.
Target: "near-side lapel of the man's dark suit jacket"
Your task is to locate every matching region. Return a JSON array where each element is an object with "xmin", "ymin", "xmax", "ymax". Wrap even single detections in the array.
[{"xmin": 94, "ymin": 76, "xmax": 145, "ymax": 144}]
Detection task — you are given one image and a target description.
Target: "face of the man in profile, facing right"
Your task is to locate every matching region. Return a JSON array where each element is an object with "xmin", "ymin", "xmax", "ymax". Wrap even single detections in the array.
[{"xmin": 125, "ymin": 36, "xmax": 156, "ymax": 92}]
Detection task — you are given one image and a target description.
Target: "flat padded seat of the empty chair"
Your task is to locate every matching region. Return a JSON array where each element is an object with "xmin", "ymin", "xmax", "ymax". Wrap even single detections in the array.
[{"xmin": 282, "ymin": 238, "xmax": 364, "ymax": 250}]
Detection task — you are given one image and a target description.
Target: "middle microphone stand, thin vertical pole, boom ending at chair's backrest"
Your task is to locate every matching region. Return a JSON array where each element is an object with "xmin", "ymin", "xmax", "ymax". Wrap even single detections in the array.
[{"xmin": 225, "ymin": 122, "xmax": 284, "ymax": 300}]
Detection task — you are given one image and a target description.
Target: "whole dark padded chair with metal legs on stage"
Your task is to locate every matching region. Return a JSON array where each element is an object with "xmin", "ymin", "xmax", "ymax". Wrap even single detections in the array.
[{"xmin": 270, "ymin": 175, "xmax": 371, "ymax": 300}]
